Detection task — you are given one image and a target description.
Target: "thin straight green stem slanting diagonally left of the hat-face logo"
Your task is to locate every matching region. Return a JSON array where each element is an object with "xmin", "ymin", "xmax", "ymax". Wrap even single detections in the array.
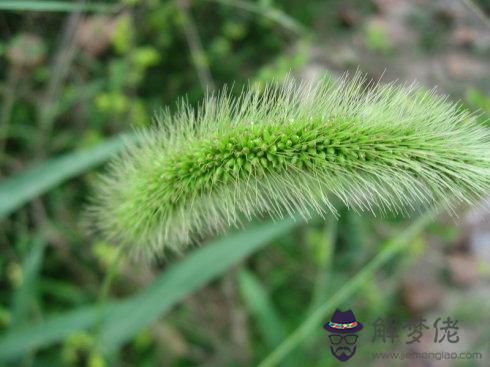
[{"xmin": 259, "ymin": 208, "xmax": 441, "ymax": 367}]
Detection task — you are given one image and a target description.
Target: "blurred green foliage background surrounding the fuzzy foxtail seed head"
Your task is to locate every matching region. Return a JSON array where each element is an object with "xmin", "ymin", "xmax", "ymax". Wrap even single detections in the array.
[{"xmin": 0, "ymin": 0, "xmax": 490, "ymax": 367}]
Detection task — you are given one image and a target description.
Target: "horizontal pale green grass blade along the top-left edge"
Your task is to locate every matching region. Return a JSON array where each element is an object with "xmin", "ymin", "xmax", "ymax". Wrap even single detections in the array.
[{"xmin": 0, "ymin": 0, "xmax": 114, "ymax": 12}]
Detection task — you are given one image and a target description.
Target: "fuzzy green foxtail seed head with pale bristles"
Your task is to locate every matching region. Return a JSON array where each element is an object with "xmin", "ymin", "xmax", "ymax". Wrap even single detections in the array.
[{"xmin": 89, "ymin": 75, "xmax": 490, "ymax": 256}]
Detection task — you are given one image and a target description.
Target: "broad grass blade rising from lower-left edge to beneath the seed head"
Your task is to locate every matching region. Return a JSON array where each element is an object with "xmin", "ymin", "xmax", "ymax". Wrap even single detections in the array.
[{"xmin": 0, "ymin": 219, "xmax": 300, "ymax": 360}]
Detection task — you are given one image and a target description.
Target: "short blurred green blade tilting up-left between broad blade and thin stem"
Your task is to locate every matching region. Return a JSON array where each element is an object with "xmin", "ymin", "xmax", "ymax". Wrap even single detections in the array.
[{"xmin": 238, "ymin": 270, "xmax": 286, "ymax": 348}]
